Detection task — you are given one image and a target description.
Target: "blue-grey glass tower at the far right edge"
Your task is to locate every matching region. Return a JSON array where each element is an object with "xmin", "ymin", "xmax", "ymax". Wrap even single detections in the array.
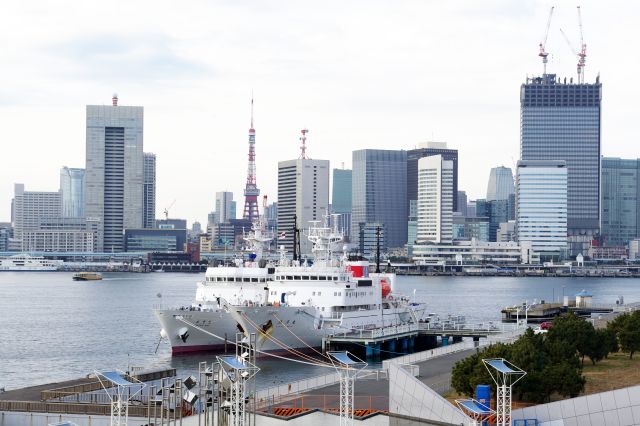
[{"xmin": 601, "ymin": 157, "xmax": 640, "ymax": 246}]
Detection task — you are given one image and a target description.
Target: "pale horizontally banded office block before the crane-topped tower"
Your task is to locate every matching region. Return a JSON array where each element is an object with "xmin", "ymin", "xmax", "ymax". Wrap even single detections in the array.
[{"xmin": 516, "ymin": 160, "xmax": 568, "ymax": 261}]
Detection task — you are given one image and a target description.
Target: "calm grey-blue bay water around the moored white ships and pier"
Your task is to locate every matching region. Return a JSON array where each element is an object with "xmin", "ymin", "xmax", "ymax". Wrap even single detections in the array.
[{"xmin": 0, "ymin": 272, "xmax": 640, "ymax": 390}]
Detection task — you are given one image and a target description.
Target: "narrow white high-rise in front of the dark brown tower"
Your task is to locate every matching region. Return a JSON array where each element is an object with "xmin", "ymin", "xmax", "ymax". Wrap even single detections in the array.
[{"xmin": 417, "ymin": 155, "xmax": 454, "ymax": 243}]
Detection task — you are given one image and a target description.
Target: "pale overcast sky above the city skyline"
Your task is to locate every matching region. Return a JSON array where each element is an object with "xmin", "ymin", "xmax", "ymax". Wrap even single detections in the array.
[{"xmin": 0, "ymin": 0, "xmax": 640, "ymax": 223}]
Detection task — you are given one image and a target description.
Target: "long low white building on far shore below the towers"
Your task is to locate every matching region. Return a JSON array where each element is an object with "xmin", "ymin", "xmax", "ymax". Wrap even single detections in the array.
[{"xmin": 413, "ymin": 238, "xmax": 522, "ymax": 265}]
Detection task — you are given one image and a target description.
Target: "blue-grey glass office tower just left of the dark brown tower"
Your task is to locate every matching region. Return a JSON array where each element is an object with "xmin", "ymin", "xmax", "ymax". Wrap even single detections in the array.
[{"xmin": 351, "ymin": 149, "xmax": 404, "ymax": 251}]
